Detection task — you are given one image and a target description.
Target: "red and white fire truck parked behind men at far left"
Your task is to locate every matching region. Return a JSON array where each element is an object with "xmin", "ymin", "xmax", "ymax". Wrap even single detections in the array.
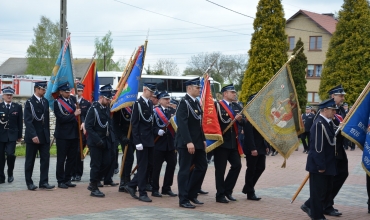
[{"xmin": 0, "ymin": 75, "xmax": 50, "ymax": 96}]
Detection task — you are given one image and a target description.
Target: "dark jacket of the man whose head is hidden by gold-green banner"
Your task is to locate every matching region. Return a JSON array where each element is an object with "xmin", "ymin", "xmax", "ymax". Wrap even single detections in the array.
[{"xmin": 243, "ymin": 121, "xmax": 267, "ymax": 155}]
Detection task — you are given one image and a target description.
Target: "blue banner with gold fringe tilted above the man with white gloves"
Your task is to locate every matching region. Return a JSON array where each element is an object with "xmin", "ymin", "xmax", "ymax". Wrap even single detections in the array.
[{"xmin": 111, "ymin": 46, "xmax": 145, "ymax": 112}]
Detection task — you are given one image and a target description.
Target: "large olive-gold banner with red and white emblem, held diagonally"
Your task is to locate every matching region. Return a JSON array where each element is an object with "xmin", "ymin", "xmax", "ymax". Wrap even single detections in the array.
[{"xmin": 243, "ymin": 64, "xmax": 304, "ymax": 167}]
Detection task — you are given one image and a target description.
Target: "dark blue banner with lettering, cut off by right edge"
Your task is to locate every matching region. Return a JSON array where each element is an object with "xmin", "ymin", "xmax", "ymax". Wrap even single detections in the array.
[{"xmin": 341, "ymin": 82, "xmax": 370, "ymax": 176}]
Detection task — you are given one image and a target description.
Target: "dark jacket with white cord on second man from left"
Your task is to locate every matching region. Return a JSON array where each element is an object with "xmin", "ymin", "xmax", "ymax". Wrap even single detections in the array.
[{"xmin": 24, "ymin": 95, "xmax": 50, "ymax": 144}]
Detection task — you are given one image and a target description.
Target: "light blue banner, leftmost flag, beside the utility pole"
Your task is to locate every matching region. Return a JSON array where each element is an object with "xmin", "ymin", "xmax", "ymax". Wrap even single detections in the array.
[{"xmin": 45, "ymin": 36, "xmax": 75, "ymax": 110}]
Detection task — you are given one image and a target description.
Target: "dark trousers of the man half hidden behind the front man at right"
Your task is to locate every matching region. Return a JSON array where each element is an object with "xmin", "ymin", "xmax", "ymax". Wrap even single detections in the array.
[{"xmin": 324, "ymin": 157, "xmax": 348, "ymax": 211}]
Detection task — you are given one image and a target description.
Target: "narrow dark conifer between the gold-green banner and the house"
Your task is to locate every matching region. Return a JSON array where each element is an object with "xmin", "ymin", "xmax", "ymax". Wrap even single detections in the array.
[{"xmin": 290, "ymin": 38, "xmax": 307, "ymax": 110}]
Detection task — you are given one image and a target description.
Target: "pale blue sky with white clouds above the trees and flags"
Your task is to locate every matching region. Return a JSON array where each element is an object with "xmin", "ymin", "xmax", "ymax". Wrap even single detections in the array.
[{"xmin": 0, "ymin": 0, "xmax": 343, "ymax": 73}]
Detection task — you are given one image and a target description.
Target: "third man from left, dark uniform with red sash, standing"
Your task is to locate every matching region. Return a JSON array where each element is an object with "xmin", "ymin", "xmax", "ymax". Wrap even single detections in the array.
[{"xmin": 54, "ymin": 82, "xmax": 81, "ymax": 189}]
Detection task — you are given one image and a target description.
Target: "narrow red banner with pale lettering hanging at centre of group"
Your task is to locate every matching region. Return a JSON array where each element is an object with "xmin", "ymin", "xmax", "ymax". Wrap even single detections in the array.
[{"xmin": 201, "ymin": 73, "xmax": 224, "ymax": 153}]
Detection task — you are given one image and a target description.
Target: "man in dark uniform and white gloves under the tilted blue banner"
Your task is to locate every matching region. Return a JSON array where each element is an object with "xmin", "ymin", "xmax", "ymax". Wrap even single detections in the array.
[{"xmin": 124, "ymin": 83, "xmax": 156, "ymax": 202}]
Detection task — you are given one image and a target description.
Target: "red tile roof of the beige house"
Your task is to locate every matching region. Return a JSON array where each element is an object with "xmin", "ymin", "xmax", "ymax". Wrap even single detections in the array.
[{"xmin": 286, "ymin": 10, "xmax": 338, "ymax": 34}]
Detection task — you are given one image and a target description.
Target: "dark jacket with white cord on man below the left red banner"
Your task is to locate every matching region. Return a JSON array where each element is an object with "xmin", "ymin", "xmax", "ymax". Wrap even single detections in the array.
[{"xmin": 85, "ymin": 102, "xmax": 114, "ymax": 147}]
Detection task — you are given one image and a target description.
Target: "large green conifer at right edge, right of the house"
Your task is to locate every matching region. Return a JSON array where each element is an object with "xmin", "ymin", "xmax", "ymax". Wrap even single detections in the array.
[{"xmin": 319, "ymin": 0, "xmax": 370, "ymax": 104}]
